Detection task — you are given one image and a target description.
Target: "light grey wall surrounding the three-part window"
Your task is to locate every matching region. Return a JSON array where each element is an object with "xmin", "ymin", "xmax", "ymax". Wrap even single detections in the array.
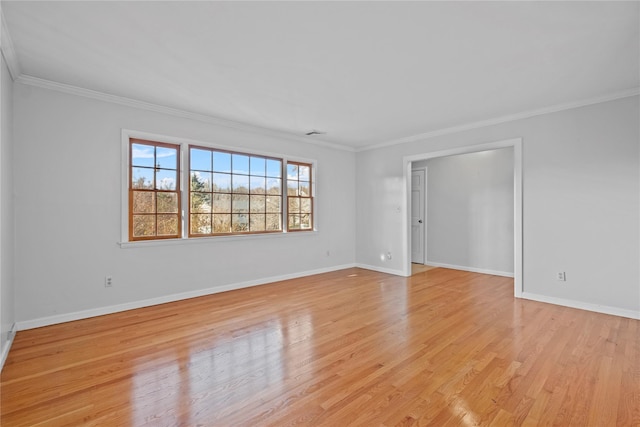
[{"xmin": 14, "ymin": 84, "xmax": 355, "ymax": 327}]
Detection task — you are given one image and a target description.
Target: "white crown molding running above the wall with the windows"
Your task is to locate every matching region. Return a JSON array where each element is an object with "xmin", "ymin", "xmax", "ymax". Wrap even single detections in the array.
[{"xmin": 15, "ymin": 74, "xmax": 356, "ymax": 152}]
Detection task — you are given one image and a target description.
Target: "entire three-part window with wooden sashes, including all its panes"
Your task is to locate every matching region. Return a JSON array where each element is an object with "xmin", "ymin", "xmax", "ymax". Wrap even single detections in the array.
[{"xmin": 122, "ymin": 135, "xmax": 314, "ymax": 246}]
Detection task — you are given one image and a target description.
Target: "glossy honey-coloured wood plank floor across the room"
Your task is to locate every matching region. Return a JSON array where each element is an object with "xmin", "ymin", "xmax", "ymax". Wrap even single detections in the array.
[{"xmin": 0, "ymin": 268, "xmax": 640, "ymax": 427}]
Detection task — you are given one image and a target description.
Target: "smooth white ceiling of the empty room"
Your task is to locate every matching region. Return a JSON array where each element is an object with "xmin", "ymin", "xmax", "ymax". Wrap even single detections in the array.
[{"xmin": 2, "ymin": 1, "xmax": 640, "ymax": 149}]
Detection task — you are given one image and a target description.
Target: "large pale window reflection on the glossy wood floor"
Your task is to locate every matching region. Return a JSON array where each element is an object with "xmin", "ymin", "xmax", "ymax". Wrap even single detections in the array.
[{"xmin": 131, "ymin": 312, "xmax": 314, "ymax": 425}]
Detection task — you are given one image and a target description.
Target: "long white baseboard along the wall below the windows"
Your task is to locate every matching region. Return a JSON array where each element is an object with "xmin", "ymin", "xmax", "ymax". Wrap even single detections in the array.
[{"xmin": 17, "ymin": 264, "xmax": 356, "ymax": 331}]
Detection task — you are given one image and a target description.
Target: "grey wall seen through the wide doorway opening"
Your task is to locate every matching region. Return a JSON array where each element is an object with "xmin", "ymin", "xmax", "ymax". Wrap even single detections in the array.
[{"xmin": 413, "ymin": 148, "xmax": 514, "ymax": 275}]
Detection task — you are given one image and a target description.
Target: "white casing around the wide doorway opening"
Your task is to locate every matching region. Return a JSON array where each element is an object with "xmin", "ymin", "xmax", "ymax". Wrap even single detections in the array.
[{"xmin": 402, "ymin": 138, "xmax": 524, "ymax": 298}]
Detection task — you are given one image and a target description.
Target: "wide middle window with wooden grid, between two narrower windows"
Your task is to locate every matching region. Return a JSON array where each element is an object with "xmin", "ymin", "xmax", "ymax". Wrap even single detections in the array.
[{"xmin": 189, "ymin": 146, "xmax": 282, "ymax": 237}]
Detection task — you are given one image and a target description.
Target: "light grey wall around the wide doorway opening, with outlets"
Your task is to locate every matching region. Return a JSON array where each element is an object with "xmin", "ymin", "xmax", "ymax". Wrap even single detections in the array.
[{"xmin": 356, "ymin": 96, "xmax": 640, "ymax": 317}]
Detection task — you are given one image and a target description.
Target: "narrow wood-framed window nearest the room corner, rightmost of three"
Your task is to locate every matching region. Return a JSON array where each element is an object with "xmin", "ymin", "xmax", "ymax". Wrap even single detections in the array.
[{"xmin": 287, "ymin": 162, "xmax": 313, "ymax": 231}]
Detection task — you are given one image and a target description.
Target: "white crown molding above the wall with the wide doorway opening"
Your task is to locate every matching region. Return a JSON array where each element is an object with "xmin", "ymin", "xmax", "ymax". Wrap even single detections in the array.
[{"xmin": 356, "ymin": 87, "xmax": 640, "ymax": 152}]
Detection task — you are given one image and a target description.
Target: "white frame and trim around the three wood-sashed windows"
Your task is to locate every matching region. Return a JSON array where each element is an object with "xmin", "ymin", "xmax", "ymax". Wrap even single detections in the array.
[{"xmin": 118, "ymin": 129, "xmax": 318, "ymax": 248}]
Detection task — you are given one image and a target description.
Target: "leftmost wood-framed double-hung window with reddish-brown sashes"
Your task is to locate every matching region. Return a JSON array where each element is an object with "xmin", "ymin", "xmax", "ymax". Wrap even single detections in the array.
[{"xmin": 129, "ymin": 139, "xmax": 181, "ymax": 240}]
